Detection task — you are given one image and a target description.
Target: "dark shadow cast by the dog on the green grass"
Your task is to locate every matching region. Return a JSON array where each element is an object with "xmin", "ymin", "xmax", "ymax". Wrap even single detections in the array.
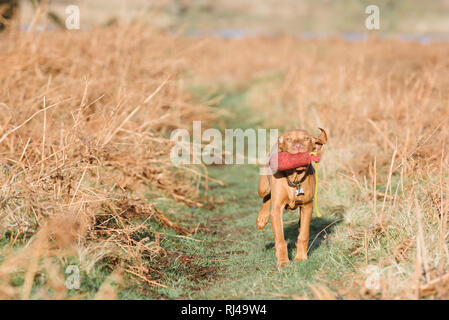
[{"xmin": 265, "ymin": 212, "xmax": 343, "ymax": 260}]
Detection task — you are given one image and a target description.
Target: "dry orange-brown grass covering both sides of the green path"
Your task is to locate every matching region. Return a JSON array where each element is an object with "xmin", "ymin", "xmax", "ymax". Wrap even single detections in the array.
[{"xmin": 0, "ymin": 16, "xmax": 449, "ymax": 298}]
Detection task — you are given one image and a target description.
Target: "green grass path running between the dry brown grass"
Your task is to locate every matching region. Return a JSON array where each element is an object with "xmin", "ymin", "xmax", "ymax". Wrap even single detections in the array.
[{"xmin": 126, "ymin": 86, "xmax": 355, "ymax": 299}]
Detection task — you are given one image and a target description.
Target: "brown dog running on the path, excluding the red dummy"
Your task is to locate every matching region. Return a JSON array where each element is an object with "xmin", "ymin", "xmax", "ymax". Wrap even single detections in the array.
[{"xmin": 257, "ymin": 128, "xmax": 327, "ymax": 267}]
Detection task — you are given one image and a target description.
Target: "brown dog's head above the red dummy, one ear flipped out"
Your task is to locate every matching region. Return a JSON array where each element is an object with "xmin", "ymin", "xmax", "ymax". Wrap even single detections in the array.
[{"xmin": 278, "ymin": 128, "xmax": 327, "ymax": 153}]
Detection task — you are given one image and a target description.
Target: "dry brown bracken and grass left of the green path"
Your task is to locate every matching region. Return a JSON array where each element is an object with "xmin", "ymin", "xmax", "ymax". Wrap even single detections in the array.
[{"xmin": 0, "ymin": 26, "xmax": 214, "ymax": 298}]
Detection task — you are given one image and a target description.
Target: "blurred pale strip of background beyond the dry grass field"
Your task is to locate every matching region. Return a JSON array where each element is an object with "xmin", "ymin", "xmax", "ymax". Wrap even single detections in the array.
[{"xmin": 0, "ymin": 0, "xmax": 449, "ymax": 37}]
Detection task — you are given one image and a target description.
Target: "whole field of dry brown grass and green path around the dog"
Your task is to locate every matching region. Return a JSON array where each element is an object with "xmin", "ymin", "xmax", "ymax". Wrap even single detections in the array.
[{"xmin": 0, "ymin": 1, "xmax": 449, "ymax": 299}]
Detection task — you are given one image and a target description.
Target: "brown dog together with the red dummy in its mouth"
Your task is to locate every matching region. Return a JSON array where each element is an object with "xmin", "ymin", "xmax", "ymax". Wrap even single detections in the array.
[{"xmin": 256, "ymin": 128, "xmax": 327, "ymax": 267}]
